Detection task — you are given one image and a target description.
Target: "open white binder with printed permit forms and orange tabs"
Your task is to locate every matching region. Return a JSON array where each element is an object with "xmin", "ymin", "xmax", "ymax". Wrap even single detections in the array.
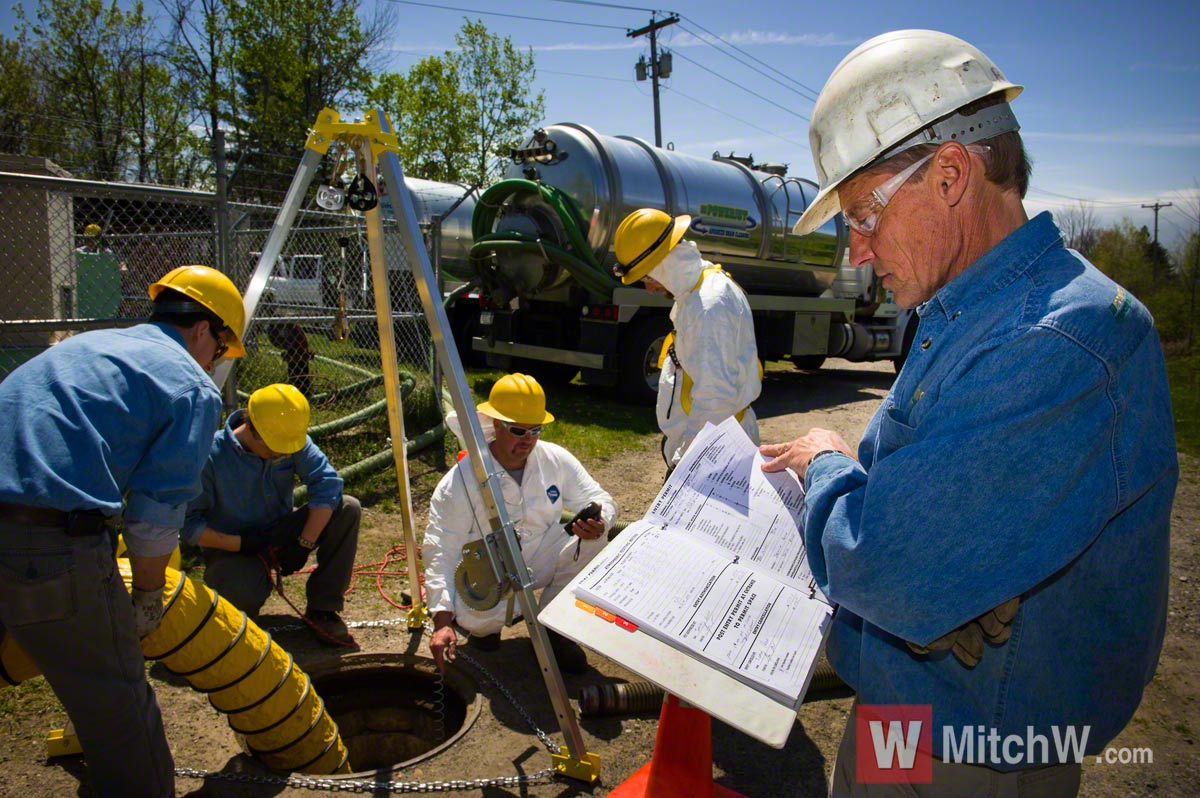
[{"xmin": 539, "ymin": 419, "xmax": 833, "ymax": 748}]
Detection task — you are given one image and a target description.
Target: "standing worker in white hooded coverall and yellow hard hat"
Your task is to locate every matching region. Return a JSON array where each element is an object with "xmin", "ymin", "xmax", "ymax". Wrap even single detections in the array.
[{"xmin": 613, "ymin": 208, "xmax": 762, "ymax": 473}]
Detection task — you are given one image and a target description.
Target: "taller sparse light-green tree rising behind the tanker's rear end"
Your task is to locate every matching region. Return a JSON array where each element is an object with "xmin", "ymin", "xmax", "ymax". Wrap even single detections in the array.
[{"xmin": 446, "ymin": 19, "xmax": 545, "ymax": 185}]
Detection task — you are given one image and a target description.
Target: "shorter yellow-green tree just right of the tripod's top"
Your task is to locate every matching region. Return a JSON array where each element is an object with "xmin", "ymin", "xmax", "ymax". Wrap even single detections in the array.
[{"xmin": 367, "ymin": 55, "xmax": 474, "ymax": 182}]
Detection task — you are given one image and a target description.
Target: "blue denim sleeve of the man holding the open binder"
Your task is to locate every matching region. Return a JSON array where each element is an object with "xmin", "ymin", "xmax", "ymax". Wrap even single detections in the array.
[{"xmin": 805, "ymin": 328, "xmax": 1117, "ymax": 644}]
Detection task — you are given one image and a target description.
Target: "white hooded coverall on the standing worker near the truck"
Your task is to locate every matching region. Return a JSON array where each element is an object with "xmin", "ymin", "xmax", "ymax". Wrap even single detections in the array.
[{"xmin": 649, "ymin": 240, "xmax": 762, "ymax": 467}]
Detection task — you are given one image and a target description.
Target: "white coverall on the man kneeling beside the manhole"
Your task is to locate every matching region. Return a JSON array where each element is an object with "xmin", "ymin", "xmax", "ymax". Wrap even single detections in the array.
[{"xmin": 421, "ymin": 440, "xmax": 617, "ymax": 635}]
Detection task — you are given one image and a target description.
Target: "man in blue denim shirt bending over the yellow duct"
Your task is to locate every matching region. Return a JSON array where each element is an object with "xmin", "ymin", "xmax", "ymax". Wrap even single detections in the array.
[{"xmin": 0, "ymin": 266, "xmax": 245, "ymax": 798}]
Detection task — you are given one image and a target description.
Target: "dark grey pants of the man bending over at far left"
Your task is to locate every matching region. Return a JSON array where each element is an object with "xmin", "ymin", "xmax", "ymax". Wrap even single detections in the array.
[{"xmin": 0, "ymin": 518, "xmax": 175, "ymax": 798}]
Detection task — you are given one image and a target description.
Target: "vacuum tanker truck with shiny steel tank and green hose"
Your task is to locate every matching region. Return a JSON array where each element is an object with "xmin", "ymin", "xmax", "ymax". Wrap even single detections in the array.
[{"xmin": 443, "ymin": 124, "xmax": 916, "ymax": 402}]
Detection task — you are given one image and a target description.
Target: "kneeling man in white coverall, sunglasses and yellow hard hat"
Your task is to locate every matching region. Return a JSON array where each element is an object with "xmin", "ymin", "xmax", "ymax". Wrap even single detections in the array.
[{"xmin": 421, "ymin": 374, "xmax": 617, "ymax": 673}]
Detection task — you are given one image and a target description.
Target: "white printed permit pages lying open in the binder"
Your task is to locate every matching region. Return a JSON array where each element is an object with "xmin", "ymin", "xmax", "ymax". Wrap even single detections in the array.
[{"xmin": 575, "ymin": 418, "xmax": 833, "ymax": 703}]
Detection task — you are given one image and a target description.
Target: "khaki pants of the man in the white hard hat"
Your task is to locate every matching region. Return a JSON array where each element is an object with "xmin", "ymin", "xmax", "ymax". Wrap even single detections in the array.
[{"xmin": 829, "ymin": 701, "xmax": 1081, "ymax": 798}]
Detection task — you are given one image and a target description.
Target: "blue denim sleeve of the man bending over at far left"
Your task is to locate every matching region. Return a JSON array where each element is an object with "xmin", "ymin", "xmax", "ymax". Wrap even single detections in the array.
[{"xmin": 125, "ymin": 385, "xmax": 221, "ymax": 529}]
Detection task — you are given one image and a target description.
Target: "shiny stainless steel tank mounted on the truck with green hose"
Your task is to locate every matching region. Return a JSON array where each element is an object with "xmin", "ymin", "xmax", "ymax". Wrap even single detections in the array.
[{"xmin": 475, "ymin": 124, "xmax": 847, "ymax": 296}]
